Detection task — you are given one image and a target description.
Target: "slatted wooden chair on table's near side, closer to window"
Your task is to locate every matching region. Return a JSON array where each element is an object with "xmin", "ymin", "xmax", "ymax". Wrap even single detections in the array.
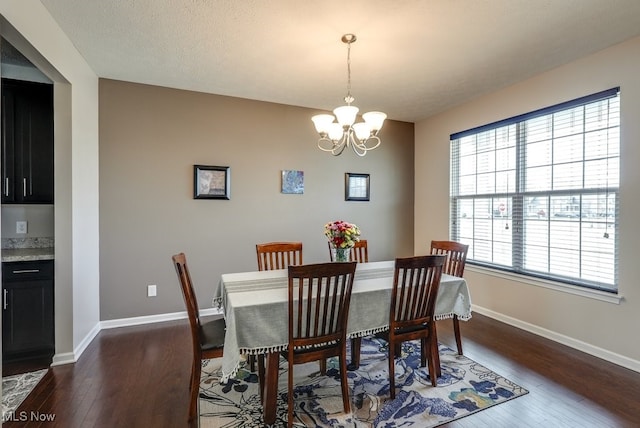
[{"xmin": 388, "ymin": 255, "xmax": 446, "ymax": 399}]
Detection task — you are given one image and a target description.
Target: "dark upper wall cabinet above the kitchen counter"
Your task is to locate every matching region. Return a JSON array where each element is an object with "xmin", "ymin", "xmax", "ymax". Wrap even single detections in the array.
[{"xmin": 1, "ymin": 79, "xmax": 53, "ymax": 204}]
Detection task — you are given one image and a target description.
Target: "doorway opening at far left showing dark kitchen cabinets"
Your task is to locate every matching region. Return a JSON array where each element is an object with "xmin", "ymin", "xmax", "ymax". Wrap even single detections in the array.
[{"xmin": 0, "ymin": 39, "xmax": 55, "ymax": 376}]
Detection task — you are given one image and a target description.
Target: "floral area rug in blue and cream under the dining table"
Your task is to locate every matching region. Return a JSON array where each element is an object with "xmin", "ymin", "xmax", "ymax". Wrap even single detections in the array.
[{"xmin": 200, "ymin": 337, "xmax": 528, "ymax": 428}]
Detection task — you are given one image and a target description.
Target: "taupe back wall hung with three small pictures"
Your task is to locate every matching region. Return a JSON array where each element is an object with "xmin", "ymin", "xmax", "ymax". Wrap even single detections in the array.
[{"xmin": 100, "ymin": 80, "xmax": 414, "ymax": 321}]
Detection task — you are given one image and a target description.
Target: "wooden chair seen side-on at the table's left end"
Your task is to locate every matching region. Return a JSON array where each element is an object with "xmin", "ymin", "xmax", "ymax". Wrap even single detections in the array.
[{"xmin": 171, "ymin": 253, "xmax": 226, "ymax": 427}]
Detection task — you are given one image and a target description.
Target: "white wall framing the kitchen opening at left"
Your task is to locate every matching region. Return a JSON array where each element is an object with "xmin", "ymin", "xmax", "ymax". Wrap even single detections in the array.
[{"xmin": 0, "ymin": 0, "xmax": 100, "ymax": 363}]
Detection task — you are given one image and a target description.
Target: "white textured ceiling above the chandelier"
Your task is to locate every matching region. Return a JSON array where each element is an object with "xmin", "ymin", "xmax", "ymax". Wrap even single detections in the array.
[{"xmin": 41, "ymin": 0, "xmax": 640, "ymax": 122}]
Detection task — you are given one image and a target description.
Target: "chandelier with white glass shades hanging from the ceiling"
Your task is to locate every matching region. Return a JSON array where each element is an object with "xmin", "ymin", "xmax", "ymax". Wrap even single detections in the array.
[{"xmin": 311, "ymin": 34, "xmax": 387, "ymax": 156}]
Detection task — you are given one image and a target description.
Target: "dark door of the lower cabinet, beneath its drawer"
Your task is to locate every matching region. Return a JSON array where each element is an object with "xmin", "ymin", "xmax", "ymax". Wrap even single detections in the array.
[{"xmin": 2, "ymin": 280, "xmax": 54, "ymax": 359}]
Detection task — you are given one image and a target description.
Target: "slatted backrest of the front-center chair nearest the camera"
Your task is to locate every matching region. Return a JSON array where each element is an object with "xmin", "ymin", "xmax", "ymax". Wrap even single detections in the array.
[{"xmin": 288, "ymin": 262, "xmax": 356, "ymax": 348}]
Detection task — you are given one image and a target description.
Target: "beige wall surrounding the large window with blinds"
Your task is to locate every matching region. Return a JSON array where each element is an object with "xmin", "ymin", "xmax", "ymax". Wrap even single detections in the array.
[{"xmin": 415, "ymin": 38, "xmax": 640, "ymax": 371}]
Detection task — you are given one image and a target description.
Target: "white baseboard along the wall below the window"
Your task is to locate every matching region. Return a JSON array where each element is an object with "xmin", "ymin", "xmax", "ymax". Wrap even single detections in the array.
[{"xmin": 472, "ymin": 305, "xmax": 640, "ymax": 373}]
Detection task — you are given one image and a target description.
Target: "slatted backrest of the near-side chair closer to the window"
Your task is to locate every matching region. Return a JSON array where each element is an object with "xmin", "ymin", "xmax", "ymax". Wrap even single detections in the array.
[{"xmin": 390, "ymin": 255, "xmax": 446, "ymax": 330}]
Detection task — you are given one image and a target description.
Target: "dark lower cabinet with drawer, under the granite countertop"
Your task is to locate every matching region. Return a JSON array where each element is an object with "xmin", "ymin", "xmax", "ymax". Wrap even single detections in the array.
[{"xmin": 2, "ymin": 260, "xmax": 55, "ymax": 361}]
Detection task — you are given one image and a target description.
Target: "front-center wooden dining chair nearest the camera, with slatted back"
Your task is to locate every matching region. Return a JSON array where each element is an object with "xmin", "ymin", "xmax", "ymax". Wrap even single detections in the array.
[{"xmin": 285, "ymin": 262, "xmax": 356, "ymax": 426}]
